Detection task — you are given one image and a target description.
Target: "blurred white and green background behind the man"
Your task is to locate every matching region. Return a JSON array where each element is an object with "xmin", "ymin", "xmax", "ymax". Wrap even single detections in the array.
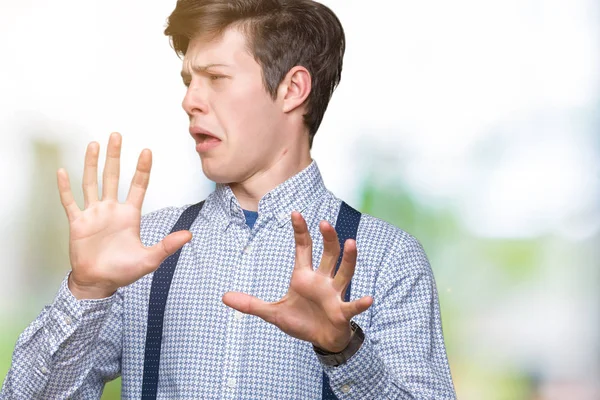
[{"xmin": 0, "ymin": 0, "xmax": 600, "ymax": 400}]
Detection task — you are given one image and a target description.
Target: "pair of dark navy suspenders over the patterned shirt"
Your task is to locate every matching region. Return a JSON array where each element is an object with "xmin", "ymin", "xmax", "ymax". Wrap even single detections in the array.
[{"xmin": 142, "ymin": 201, "xmax": 361, "ymax": 400}]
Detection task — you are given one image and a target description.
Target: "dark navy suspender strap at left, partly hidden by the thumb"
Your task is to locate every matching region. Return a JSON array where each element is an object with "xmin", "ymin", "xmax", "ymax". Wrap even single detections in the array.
[{"xmin": 142, "ymin": 201, "xmax": 204, "ymax": 400}]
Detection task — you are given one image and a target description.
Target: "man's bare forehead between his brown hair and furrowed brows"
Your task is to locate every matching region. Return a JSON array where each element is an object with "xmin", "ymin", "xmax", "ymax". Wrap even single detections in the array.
[{"xmin": 183, "ymin": 27, "xmax": 256, "ymax": 71}]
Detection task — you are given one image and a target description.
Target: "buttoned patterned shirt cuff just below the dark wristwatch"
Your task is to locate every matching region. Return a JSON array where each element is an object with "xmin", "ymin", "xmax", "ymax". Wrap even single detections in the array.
[{"xmin": 321, "ymin": 334, "xmax": 390, "ymax": 400}]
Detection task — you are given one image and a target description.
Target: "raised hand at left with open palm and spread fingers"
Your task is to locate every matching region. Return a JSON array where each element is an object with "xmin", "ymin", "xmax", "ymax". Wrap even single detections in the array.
[{"xmin": 57, "ymin": 133, "xmax": 192, "ymax": 299}]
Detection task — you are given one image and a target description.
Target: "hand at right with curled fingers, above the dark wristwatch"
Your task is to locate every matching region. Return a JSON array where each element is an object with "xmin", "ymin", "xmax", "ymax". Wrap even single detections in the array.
[{"xmin": 223, "ymin": 211, "xmax": 373, "ymax": 352}]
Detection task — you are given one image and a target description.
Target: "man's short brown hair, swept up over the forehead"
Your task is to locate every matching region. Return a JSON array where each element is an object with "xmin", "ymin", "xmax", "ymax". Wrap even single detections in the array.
[{"xmin": 165, "ymin": 0, "xmax": 346, "ymax": 148}]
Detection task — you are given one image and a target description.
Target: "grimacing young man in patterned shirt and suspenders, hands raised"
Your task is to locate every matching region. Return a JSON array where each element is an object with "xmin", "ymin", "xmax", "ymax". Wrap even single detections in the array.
[{"xmin": 0, "ymin": 0, "xmax": 455, "ymax": 399}]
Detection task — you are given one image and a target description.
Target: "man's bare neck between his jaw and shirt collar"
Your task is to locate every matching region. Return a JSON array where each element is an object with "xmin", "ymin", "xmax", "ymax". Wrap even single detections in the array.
[{"xmin": 229, "ymin": 144, "xmax": 312, "ymax": 211}]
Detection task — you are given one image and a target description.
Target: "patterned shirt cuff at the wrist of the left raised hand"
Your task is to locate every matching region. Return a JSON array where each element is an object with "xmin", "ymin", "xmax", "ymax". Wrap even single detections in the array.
[{"xmin": 43, "ymin": 272, "xmax": 116, "ymax": 361}]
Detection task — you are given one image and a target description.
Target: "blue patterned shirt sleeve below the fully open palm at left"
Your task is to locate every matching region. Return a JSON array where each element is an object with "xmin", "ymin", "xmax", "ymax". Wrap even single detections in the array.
[{"xmin": 0, "ymin": 274, "xmax": 123, "ymax": 400}]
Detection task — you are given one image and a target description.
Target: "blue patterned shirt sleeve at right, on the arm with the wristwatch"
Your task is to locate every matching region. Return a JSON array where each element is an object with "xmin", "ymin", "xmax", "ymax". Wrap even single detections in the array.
[{"xmin": 322, "ymin": 233, "xmax": 456, "ymax": 400}]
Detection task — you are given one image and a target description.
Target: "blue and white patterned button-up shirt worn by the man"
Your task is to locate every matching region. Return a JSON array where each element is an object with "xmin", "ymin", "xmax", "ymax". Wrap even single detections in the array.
[{"xmin": 0, "ymin": 160, "xmax": 455, "ymax": 400}]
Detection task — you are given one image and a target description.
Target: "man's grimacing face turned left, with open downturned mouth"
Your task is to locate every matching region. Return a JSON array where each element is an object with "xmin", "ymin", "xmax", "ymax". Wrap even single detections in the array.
[{"xmin": 182, "ymin": 28, "xmax": 284, "ymax": 183}]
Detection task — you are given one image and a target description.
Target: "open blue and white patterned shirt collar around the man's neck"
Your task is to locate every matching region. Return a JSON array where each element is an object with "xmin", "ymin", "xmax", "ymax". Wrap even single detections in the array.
[{"xmin": 205, "ymin": 160, "xmax": 327, "ymax": 231}]
